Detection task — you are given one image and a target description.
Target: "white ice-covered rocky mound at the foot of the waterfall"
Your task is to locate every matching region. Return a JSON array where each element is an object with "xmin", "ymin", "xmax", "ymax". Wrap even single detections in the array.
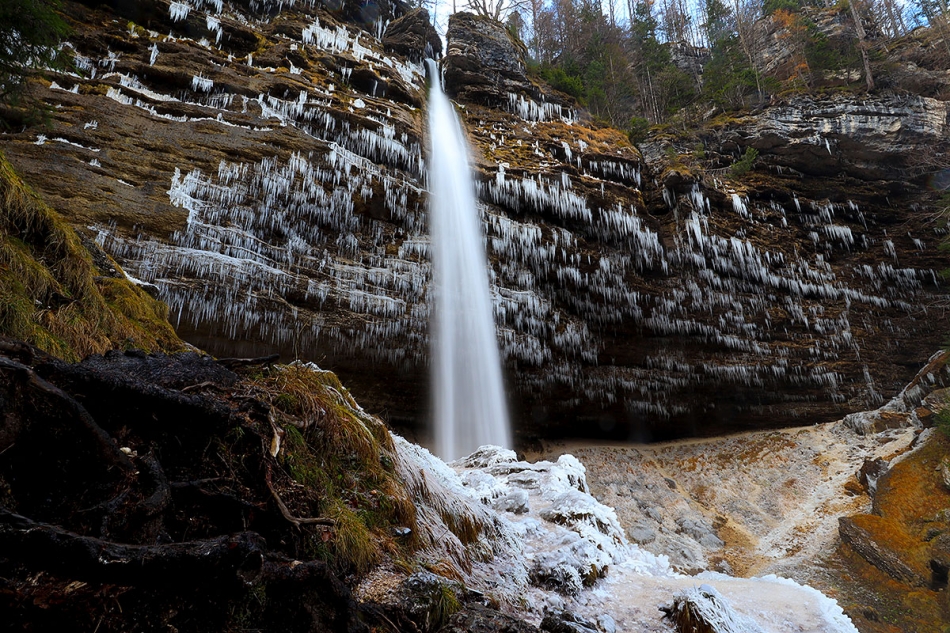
[{"xmin": 396, "ymin": 438, "xmax": 856, "ymax": 633}]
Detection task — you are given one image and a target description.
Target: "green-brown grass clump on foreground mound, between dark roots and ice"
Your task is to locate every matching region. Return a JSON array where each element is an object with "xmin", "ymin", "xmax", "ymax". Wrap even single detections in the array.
[{"xmin": 253, "ymin": 365, "xmax": 418, "ymax": 573}]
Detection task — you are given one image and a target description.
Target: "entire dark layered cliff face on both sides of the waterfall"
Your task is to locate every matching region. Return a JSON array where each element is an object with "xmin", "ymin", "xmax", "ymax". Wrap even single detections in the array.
[{"xmin": 2, "ymin": 1, "xmax": 947, "ymax": 438}]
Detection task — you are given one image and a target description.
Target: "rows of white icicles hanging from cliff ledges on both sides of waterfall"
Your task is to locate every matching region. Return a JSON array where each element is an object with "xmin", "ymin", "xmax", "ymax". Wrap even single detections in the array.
[{"xmin": 67, "ymin": 0, "xmax": 943, "ymax": 430}]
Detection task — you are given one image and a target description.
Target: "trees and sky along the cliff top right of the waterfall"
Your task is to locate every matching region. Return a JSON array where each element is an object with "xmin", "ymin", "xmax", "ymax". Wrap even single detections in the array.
[{"xmin": 432, "ymin": 0, "xmax": 950, "ymax": 133}]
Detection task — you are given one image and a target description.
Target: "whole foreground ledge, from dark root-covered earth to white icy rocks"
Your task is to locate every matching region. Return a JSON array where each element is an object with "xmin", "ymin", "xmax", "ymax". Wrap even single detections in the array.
[{"xmin": 0, "ymin": 339, "xmax": 908, "ymax": 633}]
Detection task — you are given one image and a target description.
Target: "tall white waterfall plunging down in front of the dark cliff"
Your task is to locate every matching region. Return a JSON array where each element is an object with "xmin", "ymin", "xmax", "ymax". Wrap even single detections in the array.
[{"xmin": 426, "ymin": 60, "xmax": 512, "ymax": 461}]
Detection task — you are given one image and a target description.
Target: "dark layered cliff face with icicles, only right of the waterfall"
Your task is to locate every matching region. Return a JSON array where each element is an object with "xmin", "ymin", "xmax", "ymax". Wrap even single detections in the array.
[{"xmin": 446, "ymin": 16, "xmax": 947, "ymax": 438}]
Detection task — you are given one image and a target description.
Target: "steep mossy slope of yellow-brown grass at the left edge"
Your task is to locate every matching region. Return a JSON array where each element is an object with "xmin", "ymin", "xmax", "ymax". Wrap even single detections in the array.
[{"xmin": 0, "ymin": 154, "xmax": 184, "ymax": 360}]
